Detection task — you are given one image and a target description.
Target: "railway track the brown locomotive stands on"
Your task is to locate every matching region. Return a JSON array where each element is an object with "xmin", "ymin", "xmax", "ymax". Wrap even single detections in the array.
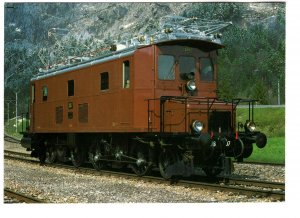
[{"xmin": 5, "ymin": 151, "xmax": 285, "ymax": 201}]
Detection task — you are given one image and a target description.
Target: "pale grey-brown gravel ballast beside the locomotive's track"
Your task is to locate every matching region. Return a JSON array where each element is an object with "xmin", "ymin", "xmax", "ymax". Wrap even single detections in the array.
[{"xmin": 4, "ymin": 142, "xmax": 284, "ymax": 203}]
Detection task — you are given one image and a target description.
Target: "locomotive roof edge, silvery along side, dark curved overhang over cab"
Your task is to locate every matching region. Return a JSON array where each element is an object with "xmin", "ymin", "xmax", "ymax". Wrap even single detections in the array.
[{"xmin": 31, "ymin": 39, "xmax": 224, "ymax": 81}]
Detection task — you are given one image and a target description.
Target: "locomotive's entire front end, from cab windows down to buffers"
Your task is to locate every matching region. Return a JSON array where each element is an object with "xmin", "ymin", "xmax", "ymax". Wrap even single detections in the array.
[{"xmin": 148, "ymin": 40, "xmax": 267, "ymax": 176}]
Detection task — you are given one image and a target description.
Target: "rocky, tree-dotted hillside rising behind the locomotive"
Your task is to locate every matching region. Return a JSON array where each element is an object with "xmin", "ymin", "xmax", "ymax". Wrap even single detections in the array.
[{"xmin": 4, "ymin": 3, "xmax": 285, "ymax": 114}]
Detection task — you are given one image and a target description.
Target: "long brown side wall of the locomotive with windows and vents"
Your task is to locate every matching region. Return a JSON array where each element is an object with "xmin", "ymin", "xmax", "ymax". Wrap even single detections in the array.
[{"xmin": 31, "ymin": 53, "xmax": 139, "ymax": 133}]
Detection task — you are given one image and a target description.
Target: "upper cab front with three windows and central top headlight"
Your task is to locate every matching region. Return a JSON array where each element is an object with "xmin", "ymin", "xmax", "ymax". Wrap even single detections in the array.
[{"xmin": 155, "ymin": 40, "xmax": 223, "ymax": 98}]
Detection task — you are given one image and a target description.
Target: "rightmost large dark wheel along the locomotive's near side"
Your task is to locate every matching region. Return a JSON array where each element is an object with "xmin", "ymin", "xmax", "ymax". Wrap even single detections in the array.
[{"xmin": 158, "ymin": 149, "xmax": 178, "ymax": 179}]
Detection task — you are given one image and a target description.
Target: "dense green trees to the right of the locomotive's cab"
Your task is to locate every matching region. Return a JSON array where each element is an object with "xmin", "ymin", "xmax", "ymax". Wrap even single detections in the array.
[{"xmin": 219, "ymin": 17, "xmax": 285, "ymax": 104}]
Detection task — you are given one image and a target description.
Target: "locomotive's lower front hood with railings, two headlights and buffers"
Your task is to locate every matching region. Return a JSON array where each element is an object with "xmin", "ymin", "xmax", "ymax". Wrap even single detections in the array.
[{"xmin": 156, "ymin": 96, "xmax": 267, "ymax": 176}]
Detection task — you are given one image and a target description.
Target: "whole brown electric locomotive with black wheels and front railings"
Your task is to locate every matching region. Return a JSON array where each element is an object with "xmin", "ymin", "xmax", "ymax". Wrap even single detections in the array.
[{"xmin": 22, "ymin": 39, "xmax": 267, "ymax": 178}]
